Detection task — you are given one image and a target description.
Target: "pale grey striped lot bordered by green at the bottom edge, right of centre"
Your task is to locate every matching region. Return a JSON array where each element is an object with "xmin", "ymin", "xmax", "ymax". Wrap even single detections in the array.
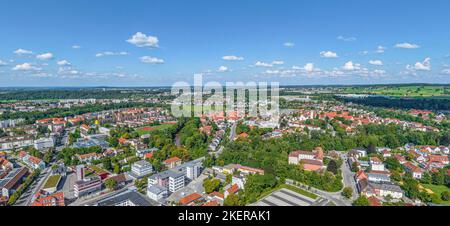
[{"xmin": 253, "ymin": 188, "xmax": 328, "ymax": 206}]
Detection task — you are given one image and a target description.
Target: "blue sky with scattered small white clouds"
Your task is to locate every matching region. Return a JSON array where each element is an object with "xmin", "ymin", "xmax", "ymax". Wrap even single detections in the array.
[{"xmin": 0, "ymin": 0, "xmax": 450, "ymax": 87}]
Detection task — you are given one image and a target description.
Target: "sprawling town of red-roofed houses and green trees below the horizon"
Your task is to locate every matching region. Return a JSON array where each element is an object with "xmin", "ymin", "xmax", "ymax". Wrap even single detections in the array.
[{"xmin": 0, "ymin": 88, "xmax": 450, "ymax": 206}]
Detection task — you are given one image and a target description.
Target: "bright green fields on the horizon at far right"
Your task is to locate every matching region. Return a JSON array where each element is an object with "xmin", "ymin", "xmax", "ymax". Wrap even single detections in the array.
[{"xmin": 342, "ymin": 85, "xmax": 450, "ymax": 97}]
